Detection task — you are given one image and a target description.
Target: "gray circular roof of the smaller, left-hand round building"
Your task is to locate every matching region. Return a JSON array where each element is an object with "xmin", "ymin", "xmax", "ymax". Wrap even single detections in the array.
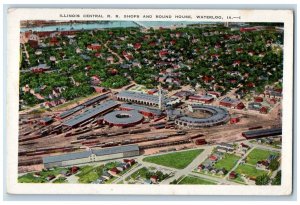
[{"xmin": 103, "ymin": 110, "xmax": 143, "ymax": 125}]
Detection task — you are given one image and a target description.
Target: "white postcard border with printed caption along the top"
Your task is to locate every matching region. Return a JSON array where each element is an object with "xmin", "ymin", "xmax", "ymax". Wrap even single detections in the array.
[{"xmin": 6, "ymin": 9, "xmax": 293, "ymax": 195}]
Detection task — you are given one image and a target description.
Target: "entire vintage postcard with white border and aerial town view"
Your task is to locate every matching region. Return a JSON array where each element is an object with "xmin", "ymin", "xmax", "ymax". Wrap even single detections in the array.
[{"xmin": 6, "ymin": 9, "xmax": 293, "ymax": 195}]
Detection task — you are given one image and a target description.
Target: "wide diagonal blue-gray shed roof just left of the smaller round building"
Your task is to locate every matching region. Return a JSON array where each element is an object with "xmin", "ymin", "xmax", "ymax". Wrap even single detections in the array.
[{"xmin": 63, "ymin": 100, "xmax": 119, "ymax": 127}]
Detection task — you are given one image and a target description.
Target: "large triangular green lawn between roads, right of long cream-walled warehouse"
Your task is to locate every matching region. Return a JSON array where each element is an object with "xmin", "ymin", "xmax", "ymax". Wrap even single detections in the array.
[{"xmin": 143, "ymin": 149, "xmax": 203, "ymax": 169}]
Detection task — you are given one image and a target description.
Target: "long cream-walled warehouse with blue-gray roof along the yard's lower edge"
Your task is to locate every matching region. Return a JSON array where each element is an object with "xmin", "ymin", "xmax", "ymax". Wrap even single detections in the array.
[{"xmin": 43, "ymin": 145, "xmax": 140, "ymax": 168}]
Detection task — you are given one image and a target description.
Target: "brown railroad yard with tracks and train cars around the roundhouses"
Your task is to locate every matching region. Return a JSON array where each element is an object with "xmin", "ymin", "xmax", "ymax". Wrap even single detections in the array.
[{"xmin": 19, "ymin": 85, "xmax": 280, "ymax": 172}]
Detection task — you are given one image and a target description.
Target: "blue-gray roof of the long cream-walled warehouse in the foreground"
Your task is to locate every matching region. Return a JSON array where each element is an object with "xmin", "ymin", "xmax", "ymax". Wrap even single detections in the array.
[{"xmin": 43, "ymin": 145, "xmax": 139, "ymax": 164}]
